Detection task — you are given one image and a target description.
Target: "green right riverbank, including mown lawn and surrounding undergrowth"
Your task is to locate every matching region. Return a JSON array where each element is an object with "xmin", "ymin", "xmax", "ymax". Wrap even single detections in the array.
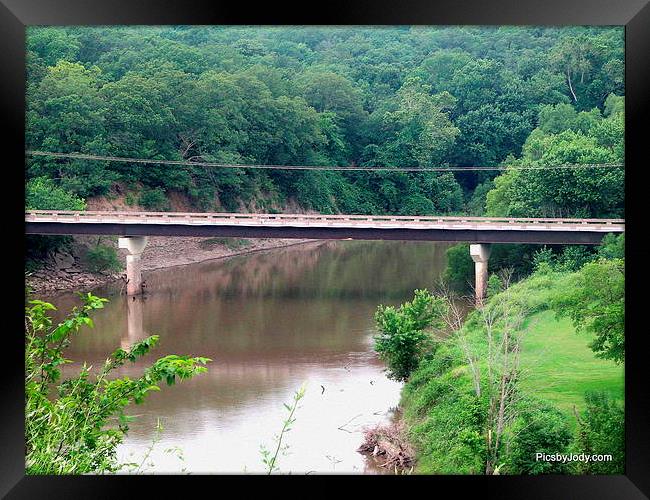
[{"xmin": 400, "ymin": 271, "xmax": 624, "ymax": 474}]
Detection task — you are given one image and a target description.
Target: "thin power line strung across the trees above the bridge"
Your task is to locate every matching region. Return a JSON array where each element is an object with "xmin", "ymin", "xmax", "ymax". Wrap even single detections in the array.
[{"xmin": 26, "ymin": 151, "xmax": 624, "ymax": 172}]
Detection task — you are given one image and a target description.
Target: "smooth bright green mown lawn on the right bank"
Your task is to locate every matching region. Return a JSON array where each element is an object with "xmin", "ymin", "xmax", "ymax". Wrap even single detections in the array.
[{"xmin": 521, "ymin": 311, "xmax": 624, "ymax": 420}]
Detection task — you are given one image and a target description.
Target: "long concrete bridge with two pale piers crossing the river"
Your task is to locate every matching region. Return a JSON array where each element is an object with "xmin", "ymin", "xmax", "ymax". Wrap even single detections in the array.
[{"xmin": 25, "ymin": 210, "xmax": 625, "ymax": 303}]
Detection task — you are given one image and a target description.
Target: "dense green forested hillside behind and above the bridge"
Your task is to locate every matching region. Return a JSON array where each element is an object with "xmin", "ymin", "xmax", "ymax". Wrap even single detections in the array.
[{"xmin": 27, "ymin": 27, "xmax": 624, "ymax": 216}]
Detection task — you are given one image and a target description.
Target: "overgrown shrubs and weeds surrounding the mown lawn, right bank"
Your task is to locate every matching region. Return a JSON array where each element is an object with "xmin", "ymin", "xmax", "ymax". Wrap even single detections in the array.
[{"xmin": 401, "ymin": 262, "xmax": 624, "ymax": 474}]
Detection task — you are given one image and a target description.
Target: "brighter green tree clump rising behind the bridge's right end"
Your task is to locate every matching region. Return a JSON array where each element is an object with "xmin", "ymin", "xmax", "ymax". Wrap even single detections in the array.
[{"xmin": 486, "ymin": 99, "xmax": 625, "ymax": 217}]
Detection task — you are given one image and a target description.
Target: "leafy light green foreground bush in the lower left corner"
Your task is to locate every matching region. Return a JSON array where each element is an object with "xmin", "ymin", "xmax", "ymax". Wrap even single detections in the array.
[{"xmin": 25, "ymin": 294, "xmax": 210, "ymax": 474}]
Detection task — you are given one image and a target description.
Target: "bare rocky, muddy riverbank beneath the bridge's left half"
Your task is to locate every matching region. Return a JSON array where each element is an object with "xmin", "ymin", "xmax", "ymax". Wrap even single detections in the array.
[{"xmin": 25, "ymin": 236, "xmax": 319, "ymax": 295}]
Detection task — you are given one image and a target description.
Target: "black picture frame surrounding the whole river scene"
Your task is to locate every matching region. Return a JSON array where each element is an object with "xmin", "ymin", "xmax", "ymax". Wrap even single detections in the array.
[{"xmin": 0, "ymin": 0, "xmax": 650, "ymax": 499}]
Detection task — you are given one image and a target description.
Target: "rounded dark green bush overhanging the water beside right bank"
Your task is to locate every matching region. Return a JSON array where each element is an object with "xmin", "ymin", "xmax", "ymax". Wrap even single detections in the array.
[{"xmin": 374, "ymin": 290, "xmax": 447, "ymax": 380}]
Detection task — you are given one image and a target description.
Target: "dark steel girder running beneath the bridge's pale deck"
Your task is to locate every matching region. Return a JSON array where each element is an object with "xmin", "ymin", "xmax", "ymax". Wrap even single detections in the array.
[{"xmin": 25, "ymin": 222, "xmax": 607, "ymax": 245}]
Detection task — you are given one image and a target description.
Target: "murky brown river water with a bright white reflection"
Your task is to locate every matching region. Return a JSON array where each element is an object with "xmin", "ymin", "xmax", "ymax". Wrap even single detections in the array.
[{"xmin": 46, "ymin": 241, "xmax": 448, "ymax": 474}]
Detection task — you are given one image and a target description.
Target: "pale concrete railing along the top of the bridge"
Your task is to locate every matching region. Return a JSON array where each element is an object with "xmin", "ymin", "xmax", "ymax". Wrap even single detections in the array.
[{"xmin": 25, "ymin": 210, "xmax": 625, "ymax": 225}]
